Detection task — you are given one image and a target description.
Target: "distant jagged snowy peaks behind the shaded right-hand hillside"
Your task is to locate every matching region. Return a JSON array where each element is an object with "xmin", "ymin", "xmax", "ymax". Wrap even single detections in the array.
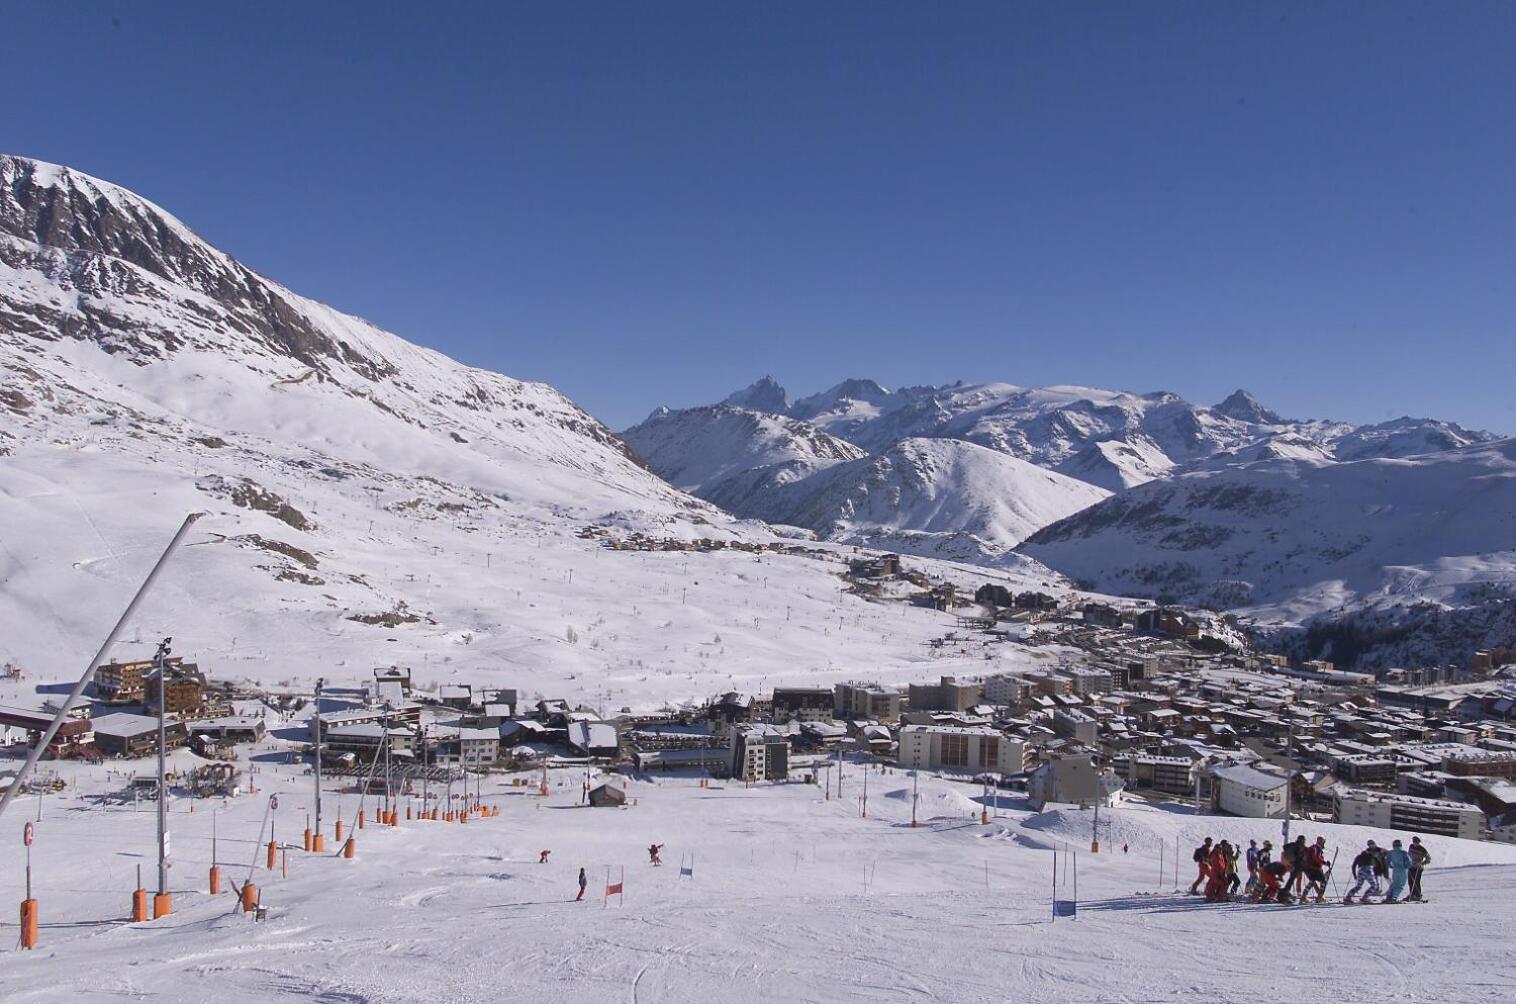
[{"xmin": 623, "ymin": 376, "xmax": 1496, "ymax": 585}]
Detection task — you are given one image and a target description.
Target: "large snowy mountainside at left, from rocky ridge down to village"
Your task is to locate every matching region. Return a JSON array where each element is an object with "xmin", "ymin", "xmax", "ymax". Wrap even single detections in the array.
[{"xmin": 0, "ymin": 158, "xmax": 1067, "ymax": 708}]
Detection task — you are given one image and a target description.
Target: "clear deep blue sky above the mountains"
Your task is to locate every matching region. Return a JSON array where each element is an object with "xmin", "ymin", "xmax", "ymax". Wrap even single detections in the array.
[{"xmin": 0, "ymin": 0, "xmax": 1516, "ymax": 432}]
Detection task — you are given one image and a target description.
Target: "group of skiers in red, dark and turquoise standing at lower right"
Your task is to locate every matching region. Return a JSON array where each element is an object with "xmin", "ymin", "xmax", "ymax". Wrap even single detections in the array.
[{"xmin": 1190, "ymin": 836, "xmax": 1431, "ymax": 905}]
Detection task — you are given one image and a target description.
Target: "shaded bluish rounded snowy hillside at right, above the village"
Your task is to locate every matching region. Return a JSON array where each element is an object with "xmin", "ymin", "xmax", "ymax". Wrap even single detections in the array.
[{"xmin": 1022, "ymin": 440, "xmax": 1516, "ymax": 617}]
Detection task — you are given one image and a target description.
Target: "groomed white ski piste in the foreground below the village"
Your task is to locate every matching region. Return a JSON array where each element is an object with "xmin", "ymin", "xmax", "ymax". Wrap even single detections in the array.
[{"xmin": 0, "ymin": 755, "xmax": 1516, "ymax": 1004}]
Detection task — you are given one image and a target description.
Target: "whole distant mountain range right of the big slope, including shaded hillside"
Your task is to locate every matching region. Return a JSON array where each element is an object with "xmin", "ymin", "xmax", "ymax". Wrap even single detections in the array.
[{"xmin": 623, "ymin": 376, "xmax": 1516, "ymax": 661}]
